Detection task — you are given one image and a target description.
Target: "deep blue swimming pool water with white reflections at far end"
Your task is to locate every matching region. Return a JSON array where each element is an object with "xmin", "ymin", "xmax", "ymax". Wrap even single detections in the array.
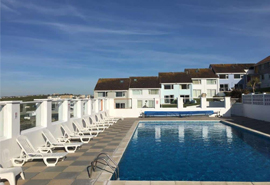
[{"xmin": 119, "ymin": 122, "xmax": 270, "ymax": 181}]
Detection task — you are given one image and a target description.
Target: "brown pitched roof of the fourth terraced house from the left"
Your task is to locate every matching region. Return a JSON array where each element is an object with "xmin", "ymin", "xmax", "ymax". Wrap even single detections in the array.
[{"xmin": 185, "ymin": 68, "xmax": 218, "ymax": 78}]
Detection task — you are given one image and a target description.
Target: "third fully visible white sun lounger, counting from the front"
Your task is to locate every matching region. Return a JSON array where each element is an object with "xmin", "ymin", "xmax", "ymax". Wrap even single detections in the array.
[{"xmin": 61, "ymin": 124, "xmax": 93, "ymax": 143}]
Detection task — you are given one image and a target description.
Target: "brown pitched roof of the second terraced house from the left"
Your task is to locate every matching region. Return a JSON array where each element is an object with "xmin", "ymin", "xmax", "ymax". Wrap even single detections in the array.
[{"xmin": 130, "ymin": 76, "xmax": 160, "ymax": 88}]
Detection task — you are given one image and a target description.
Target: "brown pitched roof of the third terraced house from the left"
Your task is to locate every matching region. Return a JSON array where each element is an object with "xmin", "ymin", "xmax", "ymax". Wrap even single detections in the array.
[{"xmin": 158, "ymin": 72, "xmax": 192, "ymax": 83}]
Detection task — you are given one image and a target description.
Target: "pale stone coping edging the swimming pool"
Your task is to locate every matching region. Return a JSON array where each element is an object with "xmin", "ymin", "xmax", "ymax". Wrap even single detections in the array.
[{"xmin": 94, "ymin": 119, "xmax": 270, "ymax": 185}]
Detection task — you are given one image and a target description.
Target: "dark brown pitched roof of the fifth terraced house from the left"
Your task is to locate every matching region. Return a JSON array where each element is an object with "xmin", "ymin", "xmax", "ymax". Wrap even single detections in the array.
[{"xmin": 210, "ymin": 63, "xmax": 255, "ymax": 73}]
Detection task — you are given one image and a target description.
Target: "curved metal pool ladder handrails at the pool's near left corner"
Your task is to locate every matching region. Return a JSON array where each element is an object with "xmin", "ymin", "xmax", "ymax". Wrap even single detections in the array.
[{"xmin": 88, "ymin": 153, "xmax": 119, "ymax": 180}]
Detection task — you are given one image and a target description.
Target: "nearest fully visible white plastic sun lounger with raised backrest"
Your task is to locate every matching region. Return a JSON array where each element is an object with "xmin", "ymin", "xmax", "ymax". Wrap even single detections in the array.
[{"xmin": 12, "ymin": 135, "xmax": 67, "ymax": 166}]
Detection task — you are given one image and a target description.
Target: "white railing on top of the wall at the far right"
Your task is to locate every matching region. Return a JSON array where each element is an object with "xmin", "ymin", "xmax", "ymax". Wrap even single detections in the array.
[{"xmin": 242, "ymin": 94, "xmax": 270, "ymax": 106}]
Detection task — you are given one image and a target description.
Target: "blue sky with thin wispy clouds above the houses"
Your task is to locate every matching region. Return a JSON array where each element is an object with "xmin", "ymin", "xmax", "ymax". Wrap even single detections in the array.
[{"xmin": 0, "ymin": 0, "xmax": 270, "ymax": 96}]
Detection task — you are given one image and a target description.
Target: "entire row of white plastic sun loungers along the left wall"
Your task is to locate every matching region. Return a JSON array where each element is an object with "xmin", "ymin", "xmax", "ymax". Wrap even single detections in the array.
[{"xmin": 0, "ymin": 112, "xmax": 121, "ymax": 185}]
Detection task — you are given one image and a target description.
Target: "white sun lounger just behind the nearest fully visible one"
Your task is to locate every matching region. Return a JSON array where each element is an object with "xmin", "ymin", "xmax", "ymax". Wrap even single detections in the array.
[{"xmin": 42, "ymin": 129, "xmax": 82, "ymax": 153}]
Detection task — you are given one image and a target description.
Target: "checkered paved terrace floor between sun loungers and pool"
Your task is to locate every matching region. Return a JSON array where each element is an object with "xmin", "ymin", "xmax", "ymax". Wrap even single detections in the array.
[{"xmin": 5, "ymin": 116, "xmax": 270, "ymax": 185}]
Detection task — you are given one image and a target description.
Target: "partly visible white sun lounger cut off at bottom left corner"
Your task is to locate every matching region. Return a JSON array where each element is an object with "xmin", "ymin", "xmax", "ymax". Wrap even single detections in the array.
[{"xmin": 0, "ymin": 165, "xmax": 25, "ymax": 185}]
